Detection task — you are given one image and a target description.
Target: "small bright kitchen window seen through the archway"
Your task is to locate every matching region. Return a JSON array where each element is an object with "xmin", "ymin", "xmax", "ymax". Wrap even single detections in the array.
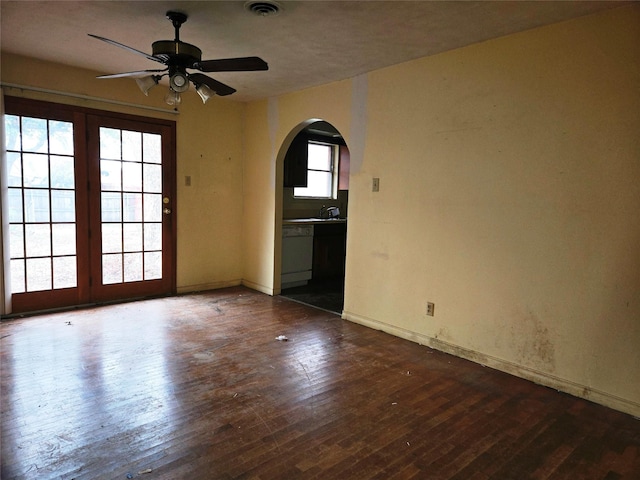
[{"xmin": 293, "ymin": 141, "xmax": 338, "ymax": 198}]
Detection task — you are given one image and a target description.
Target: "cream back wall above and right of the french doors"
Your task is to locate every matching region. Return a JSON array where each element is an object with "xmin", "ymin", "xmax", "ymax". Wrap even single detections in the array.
[{"xmin": 1, "ymin": 53, "xmax": 244, "ymax": 292}]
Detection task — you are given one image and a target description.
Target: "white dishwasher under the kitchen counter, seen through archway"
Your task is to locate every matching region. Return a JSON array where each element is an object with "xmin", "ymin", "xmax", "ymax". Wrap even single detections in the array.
[{"xmin": 281, "ymin": 225, "xmax": 313, "ymax": 289}]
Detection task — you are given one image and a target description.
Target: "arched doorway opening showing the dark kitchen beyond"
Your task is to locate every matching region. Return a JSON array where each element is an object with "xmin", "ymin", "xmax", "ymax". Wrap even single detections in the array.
[{"xmin": 281, "ymin": 120, "xmax": 350, "ymax": 314}]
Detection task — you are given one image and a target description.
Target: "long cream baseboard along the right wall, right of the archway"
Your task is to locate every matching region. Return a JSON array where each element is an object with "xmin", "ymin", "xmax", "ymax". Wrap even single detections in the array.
[{"xmin": 342, "ymin": 311, "xmax": 640, "ymax": 417}]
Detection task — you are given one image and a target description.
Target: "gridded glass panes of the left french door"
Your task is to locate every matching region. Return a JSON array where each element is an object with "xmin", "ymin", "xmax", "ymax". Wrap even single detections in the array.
[{"xmin": 5, "ymin": 115, "xmax": 77, "ymax": 293}]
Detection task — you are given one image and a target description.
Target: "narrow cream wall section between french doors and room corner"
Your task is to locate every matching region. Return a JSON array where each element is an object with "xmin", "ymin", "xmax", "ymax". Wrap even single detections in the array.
[{"xmin": 172, "ymin": 85, "xmax": 244, "ymax": 292}]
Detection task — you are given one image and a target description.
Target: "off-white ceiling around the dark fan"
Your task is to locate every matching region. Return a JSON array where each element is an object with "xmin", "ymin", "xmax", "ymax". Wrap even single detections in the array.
[{"xmin": 0, "ymin": 0, "xmax": 626, "ymax": 101}]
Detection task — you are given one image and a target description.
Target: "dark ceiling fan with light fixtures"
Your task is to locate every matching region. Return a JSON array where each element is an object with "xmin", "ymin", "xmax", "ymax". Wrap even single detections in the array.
[{"xmin": 89, "ymin": 11, "xmax": 269, "ymax": 105}]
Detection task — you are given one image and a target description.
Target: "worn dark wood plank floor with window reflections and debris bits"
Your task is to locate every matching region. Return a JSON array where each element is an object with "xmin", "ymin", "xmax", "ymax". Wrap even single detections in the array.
[{"xmin": 0, "ymin": 288, "xmax": 640, "ymax": 480}]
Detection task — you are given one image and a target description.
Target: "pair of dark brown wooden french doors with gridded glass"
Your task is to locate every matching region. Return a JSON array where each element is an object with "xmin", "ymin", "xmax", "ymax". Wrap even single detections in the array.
[{"xmin": 5, "ymin": 97, "xmax": 175, "ymax": 312}]
